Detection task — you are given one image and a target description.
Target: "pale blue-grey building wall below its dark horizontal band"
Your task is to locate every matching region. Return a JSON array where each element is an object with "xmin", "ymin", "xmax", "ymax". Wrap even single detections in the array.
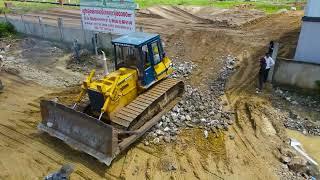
[{"xmin": 294, "ymin": 20, "xmax": 320, "ymax": 64}]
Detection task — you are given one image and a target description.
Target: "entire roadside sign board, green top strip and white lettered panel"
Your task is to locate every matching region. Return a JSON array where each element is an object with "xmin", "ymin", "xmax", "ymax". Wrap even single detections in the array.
[{"xmin": 80, "ymin": 0, "xmax": 136, "ymax": 35}]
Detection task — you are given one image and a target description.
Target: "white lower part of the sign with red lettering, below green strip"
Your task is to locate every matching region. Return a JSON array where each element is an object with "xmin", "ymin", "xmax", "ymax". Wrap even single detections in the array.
[{"xmin": 81, "ymin": 7, "xmax": 136, "ymax": 34}]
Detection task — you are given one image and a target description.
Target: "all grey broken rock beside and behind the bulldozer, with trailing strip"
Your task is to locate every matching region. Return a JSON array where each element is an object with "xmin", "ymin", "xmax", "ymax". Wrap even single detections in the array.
[{"xmin": 145, "ymin": 56, "xmax": 235, "ymax": 145}]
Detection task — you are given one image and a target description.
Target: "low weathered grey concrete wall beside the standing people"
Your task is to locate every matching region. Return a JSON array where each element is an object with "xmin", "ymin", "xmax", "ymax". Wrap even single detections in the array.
[{"xmin": 273, "ymin": 58, "xmax": 320, "ymax": 90}]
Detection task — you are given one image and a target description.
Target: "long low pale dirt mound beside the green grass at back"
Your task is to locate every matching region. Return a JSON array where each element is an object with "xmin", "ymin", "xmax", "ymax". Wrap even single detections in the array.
[{"xmin": 138, "ymin": 6, "xmax": 265, "ymax": 27}]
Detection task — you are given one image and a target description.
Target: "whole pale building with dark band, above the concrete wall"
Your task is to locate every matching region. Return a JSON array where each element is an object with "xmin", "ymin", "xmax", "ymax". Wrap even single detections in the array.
[{"xmin": 295, "ymin": 0, "xmax": 320, "ymax": 64}]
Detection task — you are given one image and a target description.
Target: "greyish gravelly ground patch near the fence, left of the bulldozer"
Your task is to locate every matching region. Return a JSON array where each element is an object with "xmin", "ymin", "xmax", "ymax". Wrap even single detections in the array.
[{"xmin": 1, "ymin": 38, "xmax": 82, "ymax": 87}]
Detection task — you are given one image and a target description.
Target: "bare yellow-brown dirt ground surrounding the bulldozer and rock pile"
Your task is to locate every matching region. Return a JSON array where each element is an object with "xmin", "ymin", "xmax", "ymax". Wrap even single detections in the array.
[{"xmin": 0, "ymin": 8, "xmax": 302, "ymax": 179}]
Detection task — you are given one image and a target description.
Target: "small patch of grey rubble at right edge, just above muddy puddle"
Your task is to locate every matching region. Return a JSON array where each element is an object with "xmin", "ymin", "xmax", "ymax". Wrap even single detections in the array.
[{"xmin": 284, "ymin": 112, "xmax": 320, "ymax": 136}]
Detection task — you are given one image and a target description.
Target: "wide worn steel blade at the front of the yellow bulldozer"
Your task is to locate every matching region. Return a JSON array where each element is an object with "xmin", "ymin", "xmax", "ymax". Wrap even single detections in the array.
[{"xmin": 38, "ymin": 100, "xmax": 119, "ymax": 166}]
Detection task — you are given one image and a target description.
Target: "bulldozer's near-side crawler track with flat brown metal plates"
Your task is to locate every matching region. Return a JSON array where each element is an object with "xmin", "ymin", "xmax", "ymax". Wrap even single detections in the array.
[{"xmin": 111, "ymin": 78, "xmax": 181, "ymax": 128}]
